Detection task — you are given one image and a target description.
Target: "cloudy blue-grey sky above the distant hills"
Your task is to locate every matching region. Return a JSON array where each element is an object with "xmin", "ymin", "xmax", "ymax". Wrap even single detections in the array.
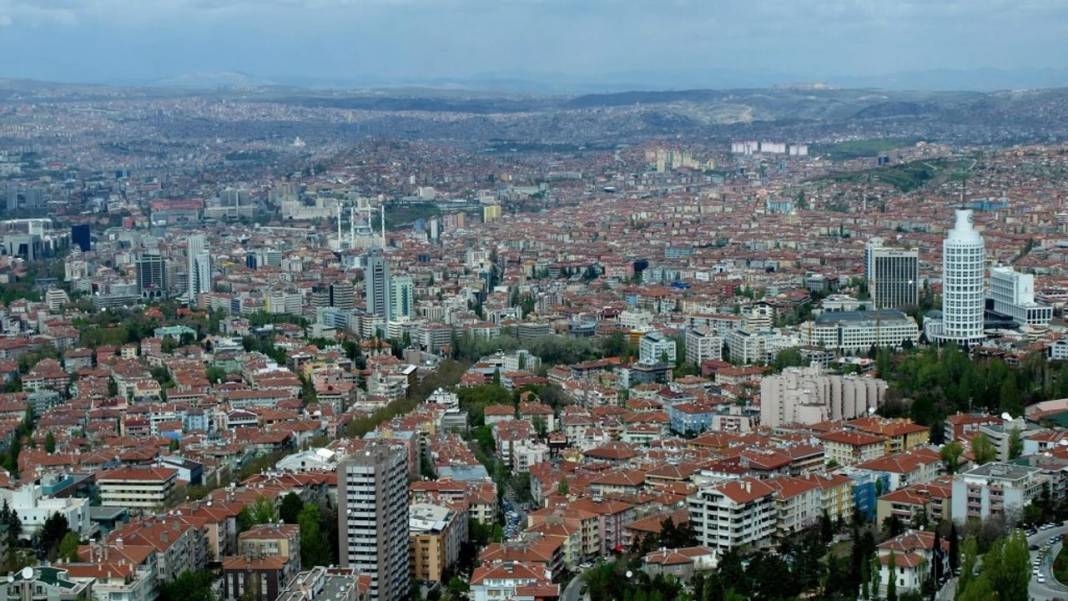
[{"xmin": 0, "ymin": 0, "xmax": 1068, "ymax": 86}]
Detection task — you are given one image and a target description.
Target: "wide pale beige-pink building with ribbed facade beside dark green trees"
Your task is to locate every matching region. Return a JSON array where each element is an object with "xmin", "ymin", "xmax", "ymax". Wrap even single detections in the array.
[{"xmin": 760, "ymin": 367, "xmax": 886, "ymax": 428}]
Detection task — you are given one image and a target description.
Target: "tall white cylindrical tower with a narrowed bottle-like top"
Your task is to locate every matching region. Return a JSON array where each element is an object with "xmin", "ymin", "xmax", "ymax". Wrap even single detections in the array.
[{"xmin": 941, "ymin": 209, "xmax": 986, "ymax": 345}]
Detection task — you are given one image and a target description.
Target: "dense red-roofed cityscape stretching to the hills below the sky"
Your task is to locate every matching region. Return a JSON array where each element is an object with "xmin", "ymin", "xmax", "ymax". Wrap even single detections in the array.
[{"xmin": 6, "ymin": 11, "xmax": 1068, "ymax": 601}]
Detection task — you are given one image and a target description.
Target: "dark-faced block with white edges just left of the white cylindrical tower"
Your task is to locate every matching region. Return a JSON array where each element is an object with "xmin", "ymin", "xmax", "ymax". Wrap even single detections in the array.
[{"xmin": 864, "ymin": 238, "xmax": 920, "ymax": 309}]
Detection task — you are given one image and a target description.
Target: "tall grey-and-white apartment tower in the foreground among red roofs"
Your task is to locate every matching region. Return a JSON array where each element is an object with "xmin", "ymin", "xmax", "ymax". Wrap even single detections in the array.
[{"xmin": 337, "ymin": 444, "xmax": 411, "ymax": 601}]
